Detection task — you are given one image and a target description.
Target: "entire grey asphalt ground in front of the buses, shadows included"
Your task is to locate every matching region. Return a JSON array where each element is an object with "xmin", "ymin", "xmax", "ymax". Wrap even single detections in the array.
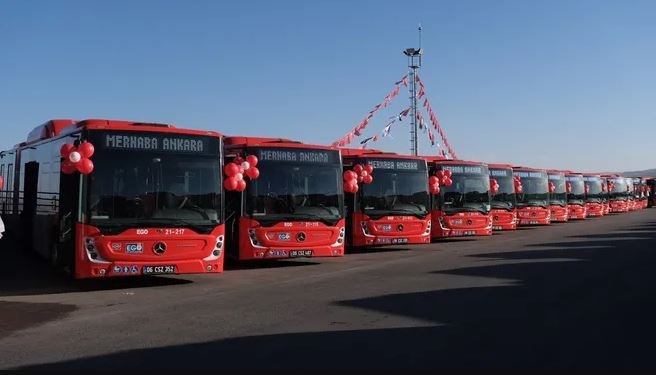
[{"xmin": 0, "ymin": 209, "xmax": 656, "ymax": 370}]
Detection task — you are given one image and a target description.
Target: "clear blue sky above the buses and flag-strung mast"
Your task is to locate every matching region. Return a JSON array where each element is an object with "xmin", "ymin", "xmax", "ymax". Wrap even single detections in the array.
[{"xmin": 0, "ymin": 0, "xmax": 656, "ymax": 170}]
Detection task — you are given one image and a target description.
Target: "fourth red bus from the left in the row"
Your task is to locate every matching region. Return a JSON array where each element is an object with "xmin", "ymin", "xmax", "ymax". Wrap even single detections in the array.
[{"xmin": 428, "ymin": 157, "xmax": 492, "ymax": 238}]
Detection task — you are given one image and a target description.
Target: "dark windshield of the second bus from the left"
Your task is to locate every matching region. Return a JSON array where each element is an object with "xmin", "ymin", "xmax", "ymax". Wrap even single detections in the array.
[{"xmin": 246, "ymin": 150, "xmax": 344, "ymax": 225}]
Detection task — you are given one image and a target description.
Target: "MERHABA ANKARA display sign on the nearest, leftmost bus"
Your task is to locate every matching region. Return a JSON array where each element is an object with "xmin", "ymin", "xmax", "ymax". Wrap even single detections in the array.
[{"xmin": 90, "ymin": 132, "xmax": 220, "ymax": 156}]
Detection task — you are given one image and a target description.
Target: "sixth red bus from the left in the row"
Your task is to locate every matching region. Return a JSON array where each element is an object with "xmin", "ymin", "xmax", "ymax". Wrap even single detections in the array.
[{"xmin": 513, "ymin": 167, "xmax": 551, "ymax": 225}]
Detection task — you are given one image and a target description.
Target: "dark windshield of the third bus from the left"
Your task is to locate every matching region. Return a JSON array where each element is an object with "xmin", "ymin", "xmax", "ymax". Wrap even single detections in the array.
[{"xmin": 360, "ymin": 159, "xmax": 429, "ymax": 219}]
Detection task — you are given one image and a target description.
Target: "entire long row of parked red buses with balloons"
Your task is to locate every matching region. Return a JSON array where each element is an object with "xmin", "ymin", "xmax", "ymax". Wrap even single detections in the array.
[{"xmin": 0, "ymin": 119, "xmax": 654, "ymax": 278}]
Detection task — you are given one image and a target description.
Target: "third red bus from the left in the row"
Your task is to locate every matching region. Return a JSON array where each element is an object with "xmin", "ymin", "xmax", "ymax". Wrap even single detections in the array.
[{"xmin": 341, "ymin": 149, "xmax": 431, "ymax": 247}]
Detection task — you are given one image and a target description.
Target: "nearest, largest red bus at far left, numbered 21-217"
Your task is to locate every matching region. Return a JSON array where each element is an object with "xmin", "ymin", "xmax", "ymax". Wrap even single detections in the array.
[{"xmin": 0, "ymin": 120, "xmax": 224, "ymax": 278}]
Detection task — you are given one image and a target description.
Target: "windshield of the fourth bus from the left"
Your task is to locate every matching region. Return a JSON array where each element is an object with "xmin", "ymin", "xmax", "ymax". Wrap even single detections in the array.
[{"xmin": 435, "ymin": 165, "xmax": 491, "ymax": 215}]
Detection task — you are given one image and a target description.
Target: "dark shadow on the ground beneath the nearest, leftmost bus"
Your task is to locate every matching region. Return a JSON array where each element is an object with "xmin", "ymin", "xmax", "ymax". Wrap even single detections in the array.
[{"xmin": 0, "ymin": 239, "xmax": 192, "ymax": 297}]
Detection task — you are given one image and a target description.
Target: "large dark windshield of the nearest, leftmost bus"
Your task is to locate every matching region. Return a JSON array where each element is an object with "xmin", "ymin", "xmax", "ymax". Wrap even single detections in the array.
[{"xmin": 86, "ymin": 134, "xmax": 223, "ymax": 233}]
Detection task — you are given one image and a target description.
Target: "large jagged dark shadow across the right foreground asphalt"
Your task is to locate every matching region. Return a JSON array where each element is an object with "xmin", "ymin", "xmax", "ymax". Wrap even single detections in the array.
[{"xmin": 19, "ymin": 220, "xmax": 656, "ymax": 372}]
